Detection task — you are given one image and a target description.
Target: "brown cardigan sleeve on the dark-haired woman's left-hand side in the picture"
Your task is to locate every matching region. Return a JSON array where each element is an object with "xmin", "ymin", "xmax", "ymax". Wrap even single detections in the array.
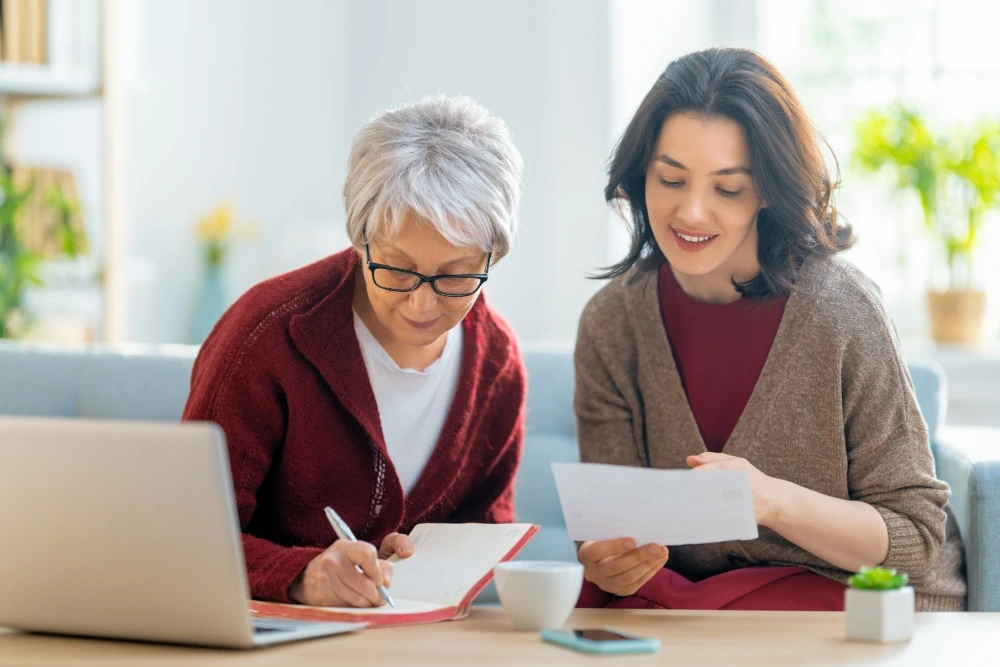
[{"xmin": 573, "ymin": 291, "xmax": 647, "ymax": 466}]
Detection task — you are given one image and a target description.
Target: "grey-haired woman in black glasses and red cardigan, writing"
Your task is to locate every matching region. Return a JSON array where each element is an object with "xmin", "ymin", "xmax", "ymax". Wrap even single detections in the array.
[{"xmin": 184, "ymin": 97, "xmax": 525, "ymax": 606}]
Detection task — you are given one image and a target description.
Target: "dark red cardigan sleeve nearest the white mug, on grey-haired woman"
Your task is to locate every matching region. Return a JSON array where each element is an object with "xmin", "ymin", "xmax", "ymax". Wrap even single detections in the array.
[{"xmin": 449, "ymin": 344, "xmax": 527, "ymax": 523}]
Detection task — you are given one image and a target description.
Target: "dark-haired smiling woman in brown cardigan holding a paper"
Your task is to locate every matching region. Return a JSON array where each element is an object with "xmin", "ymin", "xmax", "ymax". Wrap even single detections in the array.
[{"xmin": 576, "ymin": 49, "xmax": 966, "ymax": 610}]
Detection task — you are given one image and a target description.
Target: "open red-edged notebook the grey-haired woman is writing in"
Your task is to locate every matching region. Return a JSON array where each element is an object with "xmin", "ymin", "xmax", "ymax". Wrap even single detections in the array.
[{"xmin": 250, "ymin": 523, "xmax": 538, "ymax": 625}]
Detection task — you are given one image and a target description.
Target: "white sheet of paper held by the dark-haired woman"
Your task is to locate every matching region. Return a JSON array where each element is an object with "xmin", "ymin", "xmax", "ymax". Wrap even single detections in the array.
[{"xmin": 552, "ymin": 463, "xmax": 757, "ymax": 546}]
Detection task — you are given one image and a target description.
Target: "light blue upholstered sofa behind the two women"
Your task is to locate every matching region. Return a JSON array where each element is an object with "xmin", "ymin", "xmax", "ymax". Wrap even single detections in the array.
[{"xmin": 0, "ymin": 341, "xmax": 1000, "ymax": 611}]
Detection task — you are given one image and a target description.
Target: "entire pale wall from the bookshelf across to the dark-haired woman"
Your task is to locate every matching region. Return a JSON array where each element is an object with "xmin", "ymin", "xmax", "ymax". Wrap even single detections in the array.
[{"xmin": 124, "ymin": 0, "xmax": 611, "ymax": 342}]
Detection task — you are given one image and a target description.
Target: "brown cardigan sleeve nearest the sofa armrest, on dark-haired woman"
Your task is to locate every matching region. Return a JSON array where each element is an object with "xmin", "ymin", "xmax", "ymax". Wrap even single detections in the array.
[{"xmin": 841, "ymin": 298, "xmax": 949, "ymax": 577}]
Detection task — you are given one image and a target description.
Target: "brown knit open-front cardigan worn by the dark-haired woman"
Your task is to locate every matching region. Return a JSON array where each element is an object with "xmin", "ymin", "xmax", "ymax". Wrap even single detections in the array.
[{"xmin": 574, "ymin": 258, "xmax": 966, "ymax": 610}]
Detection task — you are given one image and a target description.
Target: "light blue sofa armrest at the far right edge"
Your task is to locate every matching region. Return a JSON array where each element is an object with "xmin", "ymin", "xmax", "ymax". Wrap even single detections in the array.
[{"xmin": 934, "ymin": 426, "xmax": 1000, "ymax": 611}]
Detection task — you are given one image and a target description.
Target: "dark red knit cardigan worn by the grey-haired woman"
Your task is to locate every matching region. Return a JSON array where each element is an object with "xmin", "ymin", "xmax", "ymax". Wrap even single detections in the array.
[{"xmin": 183, "ymin": 248, "xmax": 525, "ymax": 602}]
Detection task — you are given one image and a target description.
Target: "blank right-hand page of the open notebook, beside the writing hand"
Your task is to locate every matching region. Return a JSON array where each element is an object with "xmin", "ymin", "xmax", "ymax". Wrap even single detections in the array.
[{"xmin": 389, "ymin": 523, "xmax": 532, "ymax": 606}]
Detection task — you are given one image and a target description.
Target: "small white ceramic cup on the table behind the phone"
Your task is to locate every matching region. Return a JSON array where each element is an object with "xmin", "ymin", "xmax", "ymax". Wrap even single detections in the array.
[{"xmin": 493, "ymin": 560, "xmax": 583, "ymax": 630}]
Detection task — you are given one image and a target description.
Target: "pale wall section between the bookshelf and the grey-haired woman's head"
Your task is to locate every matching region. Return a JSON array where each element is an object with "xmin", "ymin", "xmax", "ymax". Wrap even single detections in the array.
[{"xmin": 120, "ymin": 0, "xmax": 347, "ymax": 342}]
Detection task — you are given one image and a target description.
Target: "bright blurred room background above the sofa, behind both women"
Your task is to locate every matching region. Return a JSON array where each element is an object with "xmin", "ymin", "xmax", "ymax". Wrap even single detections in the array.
[{"xmin": 0, "ymin": 0, "xmax": 1000, "ymax": 424}]
